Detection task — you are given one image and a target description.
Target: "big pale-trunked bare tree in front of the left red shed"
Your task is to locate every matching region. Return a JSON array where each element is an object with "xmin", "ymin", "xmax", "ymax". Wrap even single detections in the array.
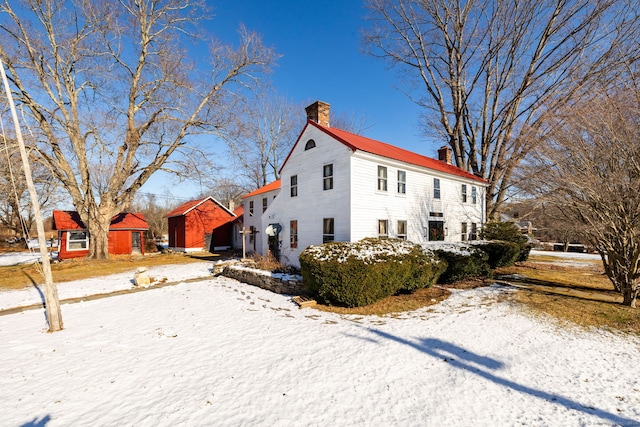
[{"xmin": 0, "ymin": 0, "xmax": 274, "ymax": 259}]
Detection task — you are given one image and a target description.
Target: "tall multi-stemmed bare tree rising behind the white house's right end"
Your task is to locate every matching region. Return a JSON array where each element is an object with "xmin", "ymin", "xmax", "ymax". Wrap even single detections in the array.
[{"xmin": 365, "ymin": 0, "xmax": 640, "ymax": 217}]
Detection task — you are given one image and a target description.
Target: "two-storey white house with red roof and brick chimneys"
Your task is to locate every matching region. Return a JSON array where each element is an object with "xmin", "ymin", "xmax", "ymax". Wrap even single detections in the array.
[{"xmin": 243, "ymin": 101, "xmax": 487, "ymax": 266}]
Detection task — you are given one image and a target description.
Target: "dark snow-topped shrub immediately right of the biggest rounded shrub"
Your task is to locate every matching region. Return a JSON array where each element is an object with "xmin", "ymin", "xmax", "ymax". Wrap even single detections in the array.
[{"xmin": 435, "ymin": 244, "xmax": 491, "ymax": 283}]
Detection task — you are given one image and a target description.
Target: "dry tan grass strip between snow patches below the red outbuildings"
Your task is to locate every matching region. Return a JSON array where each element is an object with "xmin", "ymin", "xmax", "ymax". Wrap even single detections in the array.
[{"xmin": 0, "ymin": 254, "xmax": 213, "ymax": 290}]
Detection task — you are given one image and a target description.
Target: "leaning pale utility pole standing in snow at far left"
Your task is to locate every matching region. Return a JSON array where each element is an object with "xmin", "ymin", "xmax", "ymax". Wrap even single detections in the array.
[{"xmin": 0, "ymin": 60, "xmax": 63, "ymax": 332}]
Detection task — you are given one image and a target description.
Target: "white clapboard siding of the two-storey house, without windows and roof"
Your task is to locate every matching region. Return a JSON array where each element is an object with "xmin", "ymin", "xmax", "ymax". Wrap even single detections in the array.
[{"xmin": 244, "ymin": 120, "xmax": 485, "ymax": 266}]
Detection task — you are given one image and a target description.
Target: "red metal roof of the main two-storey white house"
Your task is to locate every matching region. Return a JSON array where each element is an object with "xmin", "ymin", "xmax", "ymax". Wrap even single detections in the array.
[{"xmin": 280, "ymin": 120, "xmax": 487, "ymax": 184}]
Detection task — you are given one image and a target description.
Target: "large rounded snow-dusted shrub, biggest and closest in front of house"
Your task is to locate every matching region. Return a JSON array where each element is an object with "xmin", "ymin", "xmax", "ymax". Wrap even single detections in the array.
[{"xmin": 300, "ymin": 239, "xmax": 446, "ymax": 307}]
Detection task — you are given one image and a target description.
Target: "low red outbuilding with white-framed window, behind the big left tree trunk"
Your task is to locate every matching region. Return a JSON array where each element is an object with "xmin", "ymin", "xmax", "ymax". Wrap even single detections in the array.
[{"xmin": 53, "ymin": 211, "xmax": 149, "ymax": 261}]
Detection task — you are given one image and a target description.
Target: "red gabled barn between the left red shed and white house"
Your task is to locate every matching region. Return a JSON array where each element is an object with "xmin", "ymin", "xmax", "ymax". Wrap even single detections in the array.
[{"xmin": 165, "ymin": 197, "xmax": 236, "ymax": 252}]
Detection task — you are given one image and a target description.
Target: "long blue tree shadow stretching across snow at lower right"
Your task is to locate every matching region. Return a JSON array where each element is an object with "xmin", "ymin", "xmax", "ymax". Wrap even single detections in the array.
[{"xmin": 368, "ymin": 328, "xmax": 640, "ymax": 426}]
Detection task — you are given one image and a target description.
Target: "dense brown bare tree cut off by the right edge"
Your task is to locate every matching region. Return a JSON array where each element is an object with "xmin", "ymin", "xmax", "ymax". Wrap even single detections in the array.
[{"xmin": 523, "ymin": 87, "xmax": 640, "ymax": 307}]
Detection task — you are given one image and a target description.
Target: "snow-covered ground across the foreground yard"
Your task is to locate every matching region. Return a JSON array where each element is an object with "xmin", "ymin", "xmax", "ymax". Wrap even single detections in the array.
[{"xmin": 0, "ymin": 252, "xmax": 640, "ymax": 426}]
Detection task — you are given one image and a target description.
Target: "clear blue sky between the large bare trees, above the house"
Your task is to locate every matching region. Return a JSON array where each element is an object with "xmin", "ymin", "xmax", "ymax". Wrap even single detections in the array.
[{"xmin": 142, "ymin": 0, "xmax": 441, "ymax": 201}]
